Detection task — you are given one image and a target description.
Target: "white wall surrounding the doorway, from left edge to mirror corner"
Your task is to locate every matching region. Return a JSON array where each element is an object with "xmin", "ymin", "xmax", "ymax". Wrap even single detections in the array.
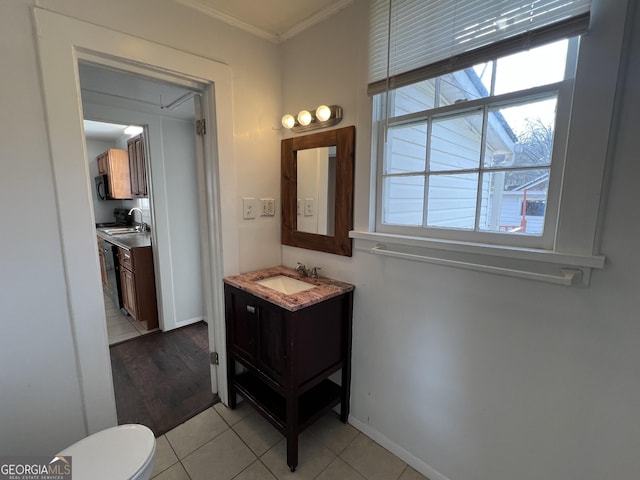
[{"xmin": 0, "ymin": 0, "xmax": 281, "ymax": 455}]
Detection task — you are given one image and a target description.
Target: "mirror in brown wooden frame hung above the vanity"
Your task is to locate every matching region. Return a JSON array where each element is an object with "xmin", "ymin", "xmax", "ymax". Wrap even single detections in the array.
[{"xmin": 280, "ymin": 126, "xmax": 356, "ymax": 257}]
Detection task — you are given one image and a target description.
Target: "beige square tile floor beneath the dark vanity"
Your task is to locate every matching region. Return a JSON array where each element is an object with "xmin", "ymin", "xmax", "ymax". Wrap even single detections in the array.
[{"xmin": 153, "ymin": 402, "xmax": 428, "ymax": 480}]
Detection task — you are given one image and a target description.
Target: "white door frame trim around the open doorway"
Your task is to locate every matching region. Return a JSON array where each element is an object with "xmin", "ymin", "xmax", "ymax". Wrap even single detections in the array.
[{"xmin": 33, "ymin": 7, "xmax": 239, "ymax": 434}]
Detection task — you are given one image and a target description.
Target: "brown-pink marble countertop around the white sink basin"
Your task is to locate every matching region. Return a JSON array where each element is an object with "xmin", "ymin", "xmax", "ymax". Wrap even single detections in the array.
[{"xmin": 224, "ymin": 266, "xmax": 356, "ymax": 312}]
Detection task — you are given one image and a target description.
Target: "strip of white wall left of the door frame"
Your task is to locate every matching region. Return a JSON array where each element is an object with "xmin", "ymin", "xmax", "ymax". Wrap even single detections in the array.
[{"xmin": 0, "ymin": 1, "xmax": 87, "ymax": 455}]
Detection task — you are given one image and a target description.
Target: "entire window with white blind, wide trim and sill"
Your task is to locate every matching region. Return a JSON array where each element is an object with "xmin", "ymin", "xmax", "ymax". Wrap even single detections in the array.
[{"xmin": 351, "ymin": 0, "xmax": 630, "ymax": 285}]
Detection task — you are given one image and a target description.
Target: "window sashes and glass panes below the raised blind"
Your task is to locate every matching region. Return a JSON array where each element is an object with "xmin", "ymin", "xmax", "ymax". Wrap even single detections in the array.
[{"xmin": 374, "ymin": 38, "xmax": 578, "ymax": 245}]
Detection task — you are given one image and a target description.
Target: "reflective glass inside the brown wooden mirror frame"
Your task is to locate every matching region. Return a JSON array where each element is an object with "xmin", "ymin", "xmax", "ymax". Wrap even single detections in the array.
[{"xmin": 296, "ymin": 145, "xmax": 336, "ymax": 236}]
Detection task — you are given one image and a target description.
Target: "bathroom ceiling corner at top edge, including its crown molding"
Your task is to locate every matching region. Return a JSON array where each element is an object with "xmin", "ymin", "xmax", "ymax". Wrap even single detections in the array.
[{"xmin": 174, "ymin": 0, "xmax": 353, "ymax": 43}]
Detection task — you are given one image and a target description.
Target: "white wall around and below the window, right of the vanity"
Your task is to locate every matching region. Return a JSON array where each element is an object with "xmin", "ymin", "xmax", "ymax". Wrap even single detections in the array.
[{"xmin": 282, "ymin": 0, "xmax": 640, "ymax": 480}]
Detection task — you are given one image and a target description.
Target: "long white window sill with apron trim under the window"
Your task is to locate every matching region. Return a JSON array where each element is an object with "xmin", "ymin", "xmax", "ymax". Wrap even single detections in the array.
[{"xmin": 349, "ymin": 231, "xmax": 605, "ymax": 287}]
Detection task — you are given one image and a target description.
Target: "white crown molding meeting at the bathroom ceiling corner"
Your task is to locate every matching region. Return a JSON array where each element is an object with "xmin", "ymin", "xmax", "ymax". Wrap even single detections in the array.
[{"xmin": 175, "ymin": 0, "xmax": 353, "ymax": 43}]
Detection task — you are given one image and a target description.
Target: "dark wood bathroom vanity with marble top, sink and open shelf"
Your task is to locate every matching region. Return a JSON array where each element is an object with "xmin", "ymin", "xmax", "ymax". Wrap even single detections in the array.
[{"xmin": 224, "ymin": 267, "xmax": 355, "ymax": 471}]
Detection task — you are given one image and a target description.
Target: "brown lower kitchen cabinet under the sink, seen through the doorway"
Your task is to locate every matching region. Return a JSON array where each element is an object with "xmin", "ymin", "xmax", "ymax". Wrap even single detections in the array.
[{"xmin": 118, "ymin": 247, "xmax": 158, "ymax": 330}]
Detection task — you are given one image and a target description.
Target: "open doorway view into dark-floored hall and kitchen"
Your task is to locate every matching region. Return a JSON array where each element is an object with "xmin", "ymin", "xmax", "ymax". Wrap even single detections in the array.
[{"xmin": 78, "ymin": 63, "xmax": 215, "ymax": 435}]
